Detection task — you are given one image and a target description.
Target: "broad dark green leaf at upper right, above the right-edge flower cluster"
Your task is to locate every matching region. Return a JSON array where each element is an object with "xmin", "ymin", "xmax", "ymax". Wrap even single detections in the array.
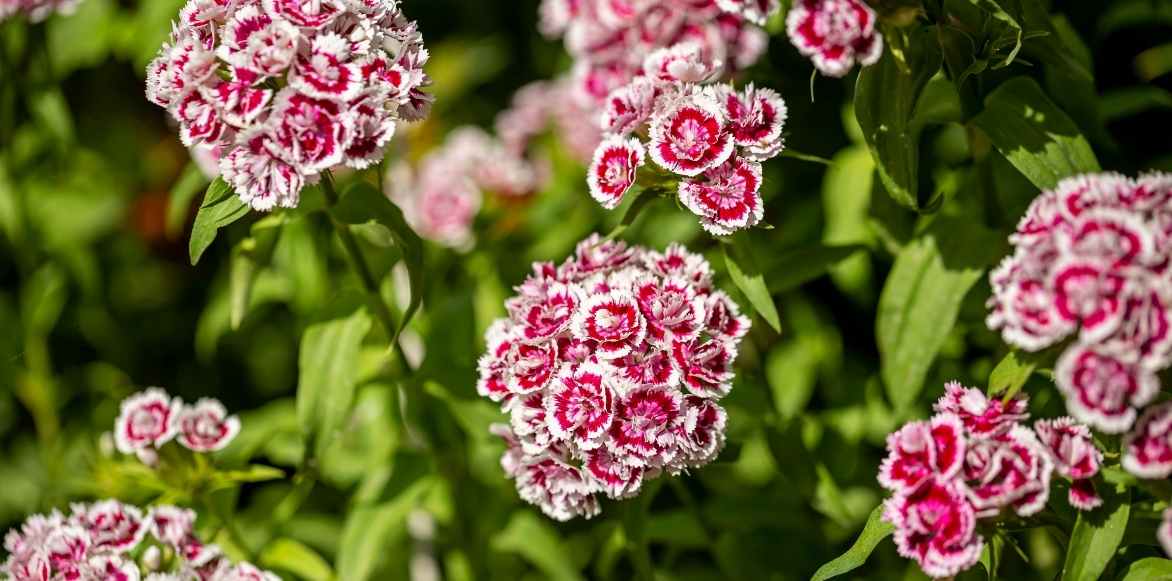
[{"xmin": 973, "ymin": 77, "xmax": 1099, "ymax": 190}]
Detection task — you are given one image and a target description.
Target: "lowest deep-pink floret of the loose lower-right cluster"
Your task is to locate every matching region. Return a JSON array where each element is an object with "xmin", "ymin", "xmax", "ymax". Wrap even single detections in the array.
[{"xmin": 884, "ymin": 478, "xmax": 984, "ymax": 577}]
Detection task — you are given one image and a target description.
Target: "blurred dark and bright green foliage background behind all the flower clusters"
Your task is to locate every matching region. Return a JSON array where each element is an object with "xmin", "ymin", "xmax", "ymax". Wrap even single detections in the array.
[{"xmin": 0, "ymin": 0, "xmax": 1172, "ymax": 580}]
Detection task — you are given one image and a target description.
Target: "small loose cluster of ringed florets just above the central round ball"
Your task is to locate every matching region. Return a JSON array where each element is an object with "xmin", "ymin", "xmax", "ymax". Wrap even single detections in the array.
[{"xmin": 587, "ymin": 72, "xmax": 786, "ymax": 235}]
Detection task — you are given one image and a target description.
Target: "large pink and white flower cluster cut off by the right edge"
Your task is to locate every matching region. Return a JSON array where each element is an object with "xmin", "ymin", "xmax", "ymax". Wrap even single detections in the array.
[{"xmin": 988, "ymin": 173, "xmax": 1172, "ymax": 433}]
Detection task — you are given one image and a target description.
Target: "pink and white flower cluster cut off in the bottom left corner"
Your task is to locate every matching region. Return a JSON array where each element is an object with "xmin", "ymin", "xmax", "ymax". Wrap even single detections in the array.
[{"xmin": 0, "ymin": 500, "xmax": 279, "ymax": 581}]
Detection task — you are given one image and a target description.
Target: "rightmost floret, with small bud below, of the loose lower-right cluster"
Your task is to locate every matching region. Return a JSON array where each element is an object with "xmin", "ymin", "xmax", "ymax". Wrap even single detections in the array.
[{"xmin": 1034, "ymin": 417, "xmax": 1103, "ymax": 511}]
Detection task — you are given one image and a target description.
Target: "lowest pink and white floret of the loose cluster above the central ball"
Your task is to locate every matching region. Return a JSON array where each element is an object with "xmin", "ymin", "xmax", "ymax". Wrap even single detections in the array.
[{"xmin": 680, "ymin": 157, "xmax": 765, "ymax": 235}]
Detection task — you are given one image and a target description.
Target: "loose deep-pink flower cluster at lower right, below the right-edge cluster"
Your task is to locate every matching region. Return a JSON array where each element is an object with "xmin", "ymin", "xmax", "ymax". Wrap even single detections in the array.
[{"xmin": 879, "ymin": 383, "xmax": 1103, "ymax": 577}]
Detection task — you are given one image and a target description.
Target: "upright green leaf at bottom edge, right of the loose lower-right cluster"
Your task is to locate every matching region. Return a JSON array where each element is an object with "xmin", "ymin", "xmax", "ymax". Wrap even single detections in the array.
[{"xmin": 1062, "ymin": 487, "xmax": 1131, "ymax": 581}]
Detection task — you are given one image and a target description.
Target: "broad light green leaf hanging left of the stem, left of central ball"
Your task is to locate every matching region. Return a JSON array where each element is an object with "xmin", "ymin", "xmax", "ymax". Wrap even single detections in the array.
[{"xmin": 297, "ymin": 309, "xmax": 370, "ymax": 454}]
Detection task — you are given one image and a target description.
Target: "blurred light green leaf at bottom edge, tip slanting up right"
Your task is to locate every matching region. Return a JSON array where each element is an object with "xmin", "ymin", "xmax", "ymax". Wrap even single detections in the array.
[{"xmin": 338, "ymin": 477, "xmax": 434, "ymax": 581}]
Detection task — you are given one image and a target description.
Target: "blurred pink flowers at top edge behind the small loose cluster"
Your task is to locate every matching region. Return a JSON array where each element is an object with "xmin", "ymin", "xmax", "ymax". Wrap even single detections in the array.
[{"xmin": 498, "ymin": 0, "xmax": 779, "ymax": 162}]
